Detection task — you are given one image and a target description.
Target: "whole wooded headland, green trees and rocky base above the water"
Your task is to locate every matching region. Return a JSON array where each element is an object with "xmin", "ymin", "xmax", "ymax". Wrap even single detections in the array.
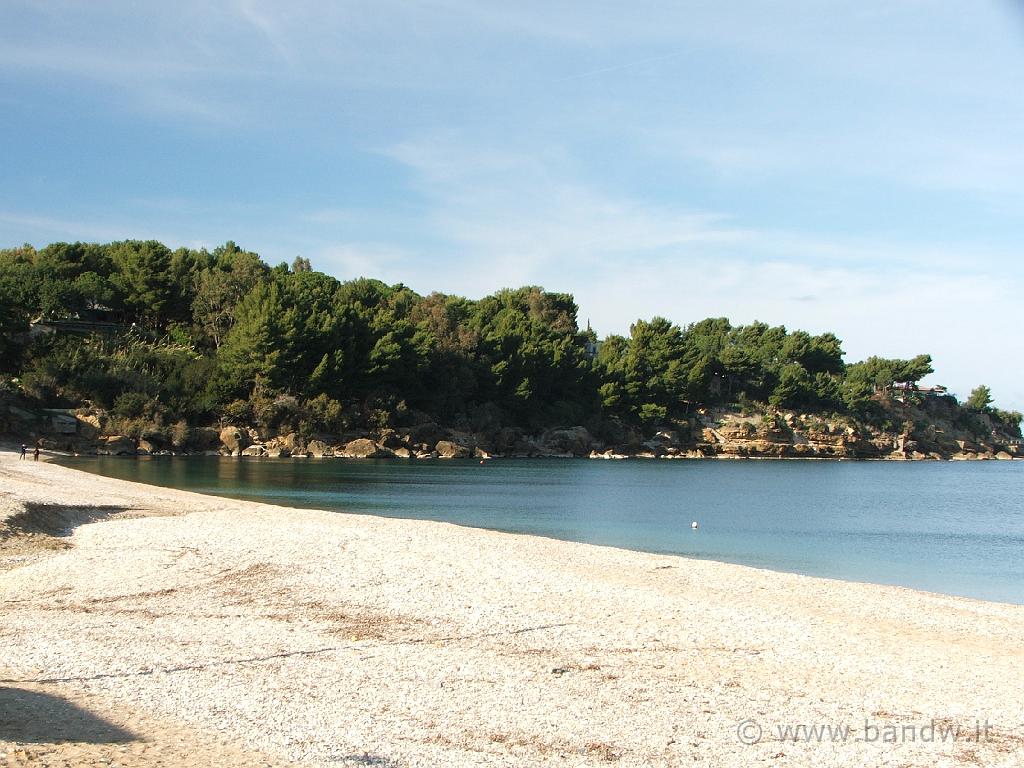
[{"xmin": 0, "ymin": 241, "xmax": 1021, "ymax": 458}]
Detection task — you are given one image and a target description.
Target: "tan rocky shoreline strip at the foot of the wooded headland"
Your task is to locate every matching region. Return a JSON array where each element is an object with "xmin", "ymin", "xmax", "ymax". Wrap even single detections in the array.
[{"xmin": 7, "ymin": 406, "xmax": 1024, "ymax": 461}]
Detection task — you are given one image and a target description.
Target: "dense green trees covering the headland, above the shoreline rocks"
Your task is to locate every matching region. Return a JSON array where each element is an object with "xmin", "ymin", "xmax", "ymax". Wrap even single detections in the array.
[{"xmin": 0, "ymin": 241, "xmax": 1021, "ymax": 444}]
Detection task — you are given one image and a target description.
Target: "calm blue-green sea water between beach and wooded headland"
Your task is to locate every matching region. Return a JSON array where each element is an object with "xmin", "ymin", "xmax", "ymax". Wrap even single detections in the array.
[{"xmin": 65, "ymin": 457, "xmax": 1024, "ymax": 603}]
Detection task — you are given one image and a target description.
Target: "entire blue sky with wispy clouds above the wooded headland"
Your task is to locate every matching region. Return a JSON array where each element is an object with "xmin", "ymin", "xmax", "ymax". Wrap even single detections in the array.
[{"xmin": 0, "ymin": 0, "xmax": 1024, "ymax": 409}]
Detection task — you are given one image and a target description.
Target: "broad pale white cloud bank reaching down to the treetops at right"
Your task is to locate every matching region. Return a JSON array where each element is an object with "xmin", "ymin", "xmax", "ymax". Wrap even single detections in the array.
[{"xmin": 376, "ymin": 139, "xmax": 1024, "ymax": 406}]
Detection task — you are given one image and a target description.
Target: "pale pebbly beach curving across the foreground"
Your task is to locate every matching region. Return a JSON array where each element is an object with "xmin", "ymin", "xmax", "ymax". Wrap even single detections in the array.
[{"xmin": 0, "ymin": 453, "xmax": 1024, "ymax": 768}]
